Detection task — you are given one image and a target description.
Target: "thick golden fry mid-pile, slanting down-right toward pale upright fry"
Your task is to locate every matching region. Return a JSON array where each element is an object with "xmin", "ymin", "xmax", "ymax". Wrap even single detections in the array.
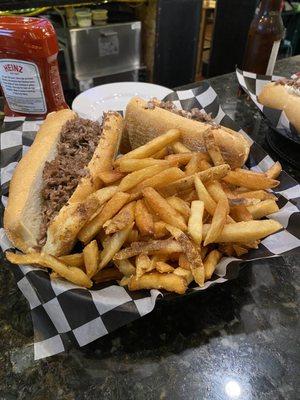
[{"xmin": 143, "ymin": 187, "xmax": 187, "ymax": 231}]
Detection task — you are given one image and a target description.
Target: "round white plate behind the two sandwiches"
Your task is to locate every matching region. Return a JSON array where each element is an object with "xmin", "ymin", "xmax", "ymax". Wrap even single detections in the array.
[{"xmin": 72, "ymin": 82, "xmax": 172, "ymax": 121}]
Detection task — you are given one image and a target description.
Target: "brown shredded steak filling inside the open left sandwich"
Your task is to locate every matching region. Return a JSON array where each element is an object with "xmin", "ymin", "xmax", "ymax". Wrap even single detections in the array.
[{"xmin": 39, "ymin": 117, "xmax": 102, "ymax": 246}]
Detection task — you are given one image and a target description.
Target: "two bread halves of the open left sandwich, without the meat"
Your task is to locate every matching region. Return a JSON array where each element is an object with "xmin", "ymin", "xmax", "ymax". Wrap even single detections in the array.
[{"xmin": 4, "ymin": 110, "xmax": 123, "ymax": 256}]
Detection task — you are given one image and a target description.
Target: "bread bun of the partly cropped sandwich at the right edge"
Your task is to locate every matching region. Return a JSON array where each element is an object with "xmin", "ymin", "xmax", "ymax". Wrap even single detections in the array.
[{"xmin": 258, "ymin": 80, "xmax": 300, "ymax": 134}]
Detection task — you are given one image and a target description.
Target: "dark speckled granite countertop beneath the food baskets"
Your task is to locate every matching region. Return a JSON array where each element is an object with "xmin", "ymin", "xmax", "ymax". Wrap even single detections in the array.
[{"xmin": 0, "ymin": 56, "xmax": 300, "ymax": 400}]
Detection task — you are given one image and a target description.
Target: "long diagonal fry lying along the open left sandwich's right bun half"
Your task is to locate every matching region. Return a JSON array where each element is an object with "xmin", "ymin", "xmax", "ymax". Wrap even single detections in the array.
[{"xmin": 78, "ymin": 192, "xmax": 130, "ymax": 243}]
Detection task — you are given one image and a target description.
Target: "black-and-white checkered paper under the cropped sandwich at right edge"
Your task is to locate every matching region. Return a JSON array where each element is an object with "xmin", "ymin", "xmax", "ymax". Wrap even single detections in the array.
[{"xmin": 236, "ymin": 68, "xmax": 300, "ymax": 144}]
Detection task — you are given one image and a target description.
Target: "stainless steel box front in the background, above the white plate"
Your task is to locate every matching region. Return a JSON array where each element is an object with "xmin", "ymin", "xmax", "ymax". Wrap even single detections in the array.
[{"xmin": 70, "ymin": 21, "xmax": 141, "ymax": 82}]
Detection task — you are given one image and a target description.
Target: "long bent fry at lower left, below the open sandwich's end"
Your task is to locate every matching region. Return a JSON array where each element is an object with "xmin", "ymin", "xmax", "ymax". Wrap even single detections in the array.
[{"xmin": 5, "ymin": 251, "xmax": 93, "ymax": 288}]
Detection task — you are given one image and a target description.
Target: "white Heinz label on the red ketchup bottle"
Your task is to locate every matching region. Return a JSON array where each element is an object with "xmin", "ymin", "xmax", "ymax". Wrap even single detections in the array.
[{"xmin": 0, "ymin": 58, "xmax": 47, "ymax": 114}]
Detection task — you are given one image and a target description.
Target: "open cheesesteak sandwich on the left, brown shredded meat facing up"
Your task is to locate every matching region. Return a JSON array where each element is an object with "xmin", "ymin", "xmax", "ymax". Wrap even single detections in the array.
[{"xmin": 4, "ymin": 110, "xmax": 123, "ymax": 256}]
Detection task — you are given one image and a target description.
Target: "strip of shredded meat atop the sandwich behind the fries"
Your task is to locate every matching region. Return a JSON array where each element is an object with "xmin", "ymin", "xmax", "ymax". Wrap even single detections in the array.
[{"xmin": 147, "ymin": 98, "xmax": 219, "ymax": 128}]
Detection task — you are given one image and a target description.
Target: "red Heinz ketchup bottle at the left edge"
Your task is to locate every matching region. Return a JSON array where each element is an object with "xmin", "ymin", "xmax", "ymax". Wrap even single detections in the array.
[{"xmin": 0, "ymin": 16, "xmax": 68, "ymax": 118}]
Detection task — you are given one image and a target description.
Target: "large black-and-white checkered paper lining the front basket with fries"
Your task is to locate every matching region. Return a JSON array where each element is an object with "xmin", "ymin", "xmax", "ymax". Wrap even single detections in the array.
[{"xmin": 0, "ymin": 82, "xmax": 300, "ymax": 359}]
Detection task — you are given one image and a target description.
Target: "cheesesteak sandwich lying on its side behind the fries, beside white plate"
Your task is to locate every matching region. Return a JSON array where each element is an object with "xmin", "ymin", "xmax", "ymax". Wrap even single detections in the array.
[{"xmin": 125, "ymin": 97, "xmax": 250, "ymax": 169}]
